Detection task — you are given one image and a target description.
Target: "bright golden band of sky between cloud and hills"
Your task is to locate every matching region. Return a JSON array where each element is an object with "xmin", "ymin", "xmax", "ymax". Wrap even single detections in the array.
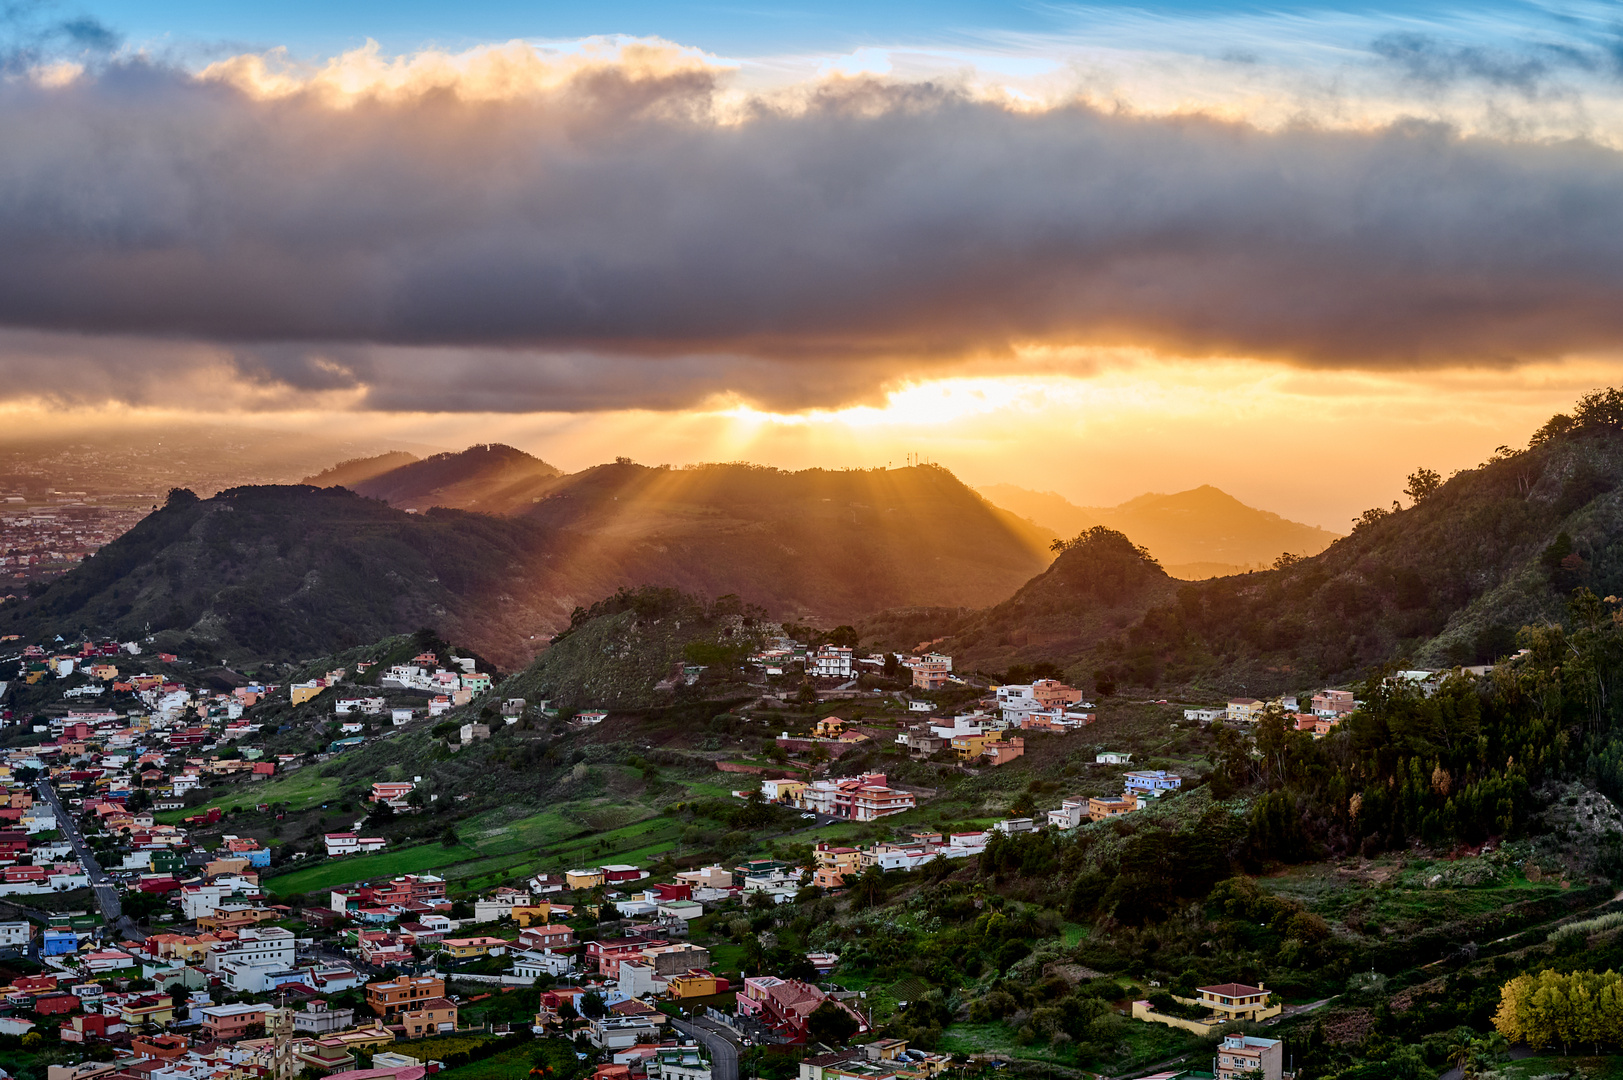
[{"xmin": 0, "ymin": 357, "xmax": 1597, "ymax": 531}]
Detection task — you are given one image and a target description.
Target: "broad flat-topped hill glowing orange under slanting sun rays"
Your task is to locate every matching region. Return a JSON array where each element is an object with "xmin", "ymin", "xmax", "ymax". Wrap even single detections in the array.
[{"xmin": 523, "ymin": 463, "xmax": 1050, "ymax": 620}]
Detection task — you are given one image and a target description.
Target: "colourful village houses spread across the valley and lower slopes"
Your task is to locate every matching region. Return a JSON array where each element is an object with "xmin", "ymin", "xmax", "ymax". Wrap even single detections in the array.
[{"xmin": 0, "ymin": 607, "xmax": 1577, "ymax": 1080}]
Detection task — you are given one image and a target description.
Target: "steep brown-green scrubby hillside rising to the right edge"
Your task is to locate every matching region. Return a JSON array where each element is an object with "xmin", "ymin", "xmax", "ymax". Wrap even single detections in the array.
[{"xmin": 941, "ymin": 402, "xmax": 1623, "ymax": 697}]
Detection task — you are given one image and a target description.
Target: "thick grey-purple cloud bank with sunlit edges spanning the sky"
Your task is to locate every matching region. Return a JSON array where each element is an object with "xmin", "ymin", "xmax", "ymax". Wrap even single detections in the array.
[{"xmin": 0, "ymin": 39, "xmax": 1623, "ymax": 409}]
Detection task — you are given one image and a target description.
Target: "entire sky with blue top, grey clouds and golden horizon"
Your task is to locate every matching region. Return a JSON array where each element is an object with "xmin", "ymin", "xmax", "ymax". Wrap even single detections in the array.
[{"xmin": 0, "ymin": 0, "xmax": 1623, "ymax": 531}]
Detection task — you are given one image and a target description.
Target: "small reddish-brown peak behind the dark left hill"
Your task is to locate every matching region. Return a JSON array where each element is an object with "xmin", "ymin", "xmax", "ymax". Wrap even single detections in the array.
[{"xmin": 349, "ymin": 443, "xmax": 563, "ymax": 513}]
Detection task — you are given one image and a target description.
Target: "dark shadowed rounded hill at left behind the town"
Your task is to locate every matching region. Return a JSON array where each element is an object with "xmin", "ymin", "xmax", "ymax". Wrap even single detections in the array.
[{"xmin": 0, "ymin": 486, "xmax": 570, "ymax": 667}]
